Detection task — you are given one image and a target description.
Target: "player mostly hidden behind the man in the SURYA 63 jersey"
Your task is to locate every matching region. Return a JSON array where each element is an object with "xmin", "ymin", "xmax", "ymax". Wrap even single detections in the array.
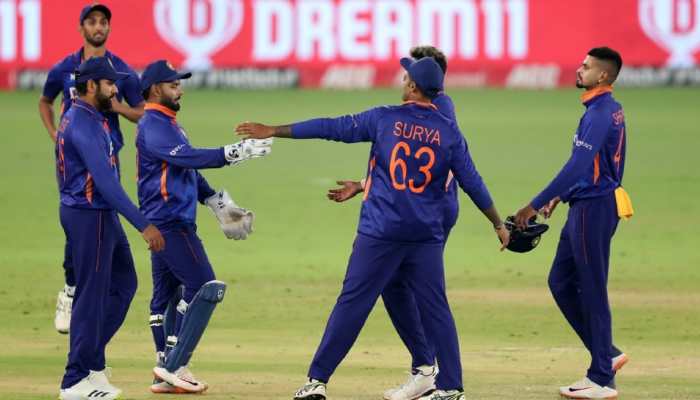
[{"xmin": 328, "ymin": 46, "xmax": 459, "ymax": 400}]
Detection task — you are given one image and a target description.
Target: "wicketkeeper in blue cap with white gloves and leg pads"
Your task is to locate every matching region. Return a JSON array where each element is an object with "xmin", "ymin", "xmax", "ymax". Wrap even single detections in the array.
[{"xmin": 136, "ymin": 60, "xmax": 272, "ymax": 393}]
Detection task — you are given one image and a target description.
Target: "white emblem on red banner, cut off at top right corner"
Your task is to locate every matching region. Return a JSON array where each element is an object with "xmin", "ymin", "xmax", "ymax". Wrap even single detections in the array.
[{"xmin": 639, "ymin": 0, "xmax": 700, "ymax": 68}]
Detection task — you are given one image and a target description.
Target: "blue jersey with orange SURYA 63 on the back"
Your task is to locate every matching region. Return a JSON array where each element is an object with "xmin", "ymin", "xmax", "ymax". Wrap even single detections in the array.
[{"xmin": 292, "ymin": 103, "xmax": 493, "ymax": 243}]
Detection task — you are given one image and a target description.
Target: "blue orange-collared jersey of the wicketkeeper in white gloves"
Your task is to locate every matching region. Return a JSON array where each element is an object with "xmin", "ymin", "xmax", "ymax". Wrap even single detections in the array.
[{"xmin": 136, "ymin": 103, "xmax": 228, "ymax": 228}]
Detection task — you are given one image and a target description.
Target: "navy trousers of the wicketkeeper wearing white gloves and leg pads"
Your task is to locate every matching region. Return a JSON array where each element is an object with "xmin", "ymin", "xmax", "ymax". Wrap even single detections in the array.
[{"xmin": 151, "ymin": 224, "xmax": 216, "ymax": 351}]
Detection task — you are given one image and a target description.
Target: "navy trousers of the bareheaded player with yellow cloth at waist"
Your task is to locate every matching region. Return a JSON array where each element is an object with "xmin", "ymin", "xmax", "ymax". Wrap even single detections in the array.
[{"xmin": 549, "ymin": 193, "xmax": 619, "ymax": 386}]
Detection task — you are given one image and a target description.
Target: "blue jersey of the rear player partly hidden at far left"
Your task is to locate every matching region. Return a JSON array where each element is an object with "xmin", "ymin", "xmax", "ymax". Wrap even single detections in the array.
[{"xmin": 43, "ymin": 48, "xmax": 143, "ymax": 163}]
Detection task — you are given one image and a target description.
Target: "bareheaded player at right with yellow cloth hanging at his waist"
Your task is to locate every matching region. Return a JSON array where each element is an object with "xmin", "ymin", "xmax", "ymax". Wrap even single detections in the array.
[{"xmin": 516, "ymin": 47, "xmax": 632, "ymax": 399}]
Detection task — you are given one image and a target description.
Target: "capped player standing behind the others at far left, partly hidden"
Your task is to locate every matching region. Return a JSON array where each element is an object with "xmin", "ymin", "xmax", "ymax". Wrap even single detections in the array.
[{"xmin": 39, "ymin": 4, "xmax": 143, "ymax": 333}]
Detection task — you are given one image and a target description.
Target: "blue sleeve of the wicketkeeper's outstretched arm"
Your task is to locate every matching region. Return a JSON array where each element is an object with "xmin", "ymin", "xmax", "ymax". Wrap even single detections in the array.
[{"xmin": 139, "ymin": 123, "xmax": 227, "ymax": 169}]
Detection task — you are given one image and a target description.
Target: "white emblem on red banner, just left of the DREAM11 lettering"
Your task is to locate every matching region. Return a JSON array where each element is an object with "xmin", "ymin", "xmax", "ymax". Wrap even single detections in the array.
[{"xmin": 153, "ymin": 0, "xmax": 243, "ymax": 70}]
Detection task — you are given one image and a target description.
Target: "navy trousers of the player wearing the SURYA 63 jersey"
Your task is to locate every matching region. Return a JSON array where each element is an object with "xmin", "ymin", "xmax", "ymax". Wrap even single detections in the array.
[{"xmin": 308, "ymin": 234, "xmax": 462, "ymax": 390}]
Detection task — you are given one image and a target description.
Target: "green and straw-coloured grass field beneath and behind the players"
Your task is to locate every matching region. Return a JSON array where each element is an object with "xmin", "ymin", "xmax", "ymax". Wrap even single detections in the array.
[{"xmin": 0, "ymin": 89, "xmax": 700, "ymax": 400}]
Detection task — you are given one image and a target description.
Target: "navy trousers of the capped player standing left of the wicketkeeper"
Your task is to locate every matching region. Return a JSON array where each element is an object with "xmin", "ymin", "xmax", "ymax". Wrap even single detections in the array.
[{"xmin": 60, "ymin": 206, "xmax": 137, "ymax": 389}]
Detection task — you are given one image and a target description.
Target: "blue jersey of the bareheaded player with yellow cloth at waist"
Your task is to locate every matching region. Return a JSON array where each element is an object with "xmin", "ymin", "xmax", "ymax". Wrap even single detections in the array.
[{"xmin": 531, "ymin": 87, "xmax": 627, "ymax": 210}]
